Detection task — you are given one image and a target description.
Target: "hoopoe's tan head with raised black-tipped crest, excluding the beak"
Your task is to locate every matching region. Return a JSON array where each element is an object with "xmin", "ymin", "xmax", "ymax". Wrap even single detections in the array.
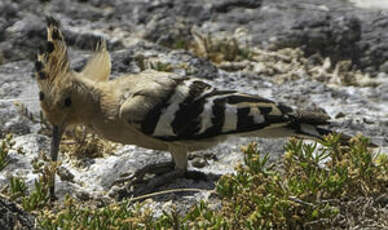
[{"xmin": 35, "ymin": 17, "xmax": 111, "ymax": 128}]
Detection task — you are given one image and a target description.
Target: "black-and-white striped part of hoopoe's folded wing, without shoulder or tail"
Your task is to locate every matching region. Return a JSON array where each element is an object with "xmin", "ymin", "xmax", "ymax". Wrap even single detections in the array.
[{"xmin": 141, "ymin": 79, "xmax": 290, "ymax": 141}]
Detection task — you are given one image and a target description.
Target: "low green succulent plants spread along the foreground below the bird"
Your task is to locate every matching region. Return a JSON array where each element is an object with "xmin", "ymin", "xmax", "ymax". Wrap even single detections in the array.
[{"xmin": 3, "ymin": 132, "xmax": 388, "ymax": 229}]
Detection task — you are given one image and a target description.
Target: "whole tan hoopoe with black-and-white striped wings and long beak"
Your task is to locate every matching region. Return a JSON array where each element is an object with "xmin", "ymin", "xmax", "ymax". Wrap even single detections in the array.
[{"xmin": 35, "ymin": 17, "xmax": 348, "ymax": 197}]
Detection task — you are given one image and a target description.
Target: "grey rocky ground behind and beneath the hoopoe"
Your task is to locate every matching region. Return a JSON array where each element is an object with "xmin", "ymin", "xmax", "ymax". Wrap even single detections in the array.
[{"xmin": 0, "ymin": 0, "xmax": 388, "ymax": 228}]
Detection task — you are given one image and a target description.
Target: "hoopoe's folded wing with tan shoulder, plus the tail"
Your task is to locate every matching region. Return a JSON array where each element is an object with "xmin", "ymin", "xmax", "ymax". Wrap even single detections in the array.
[{"xmin": 113, "ymin": 73, "xmax": 328, "ymax": 149}]
